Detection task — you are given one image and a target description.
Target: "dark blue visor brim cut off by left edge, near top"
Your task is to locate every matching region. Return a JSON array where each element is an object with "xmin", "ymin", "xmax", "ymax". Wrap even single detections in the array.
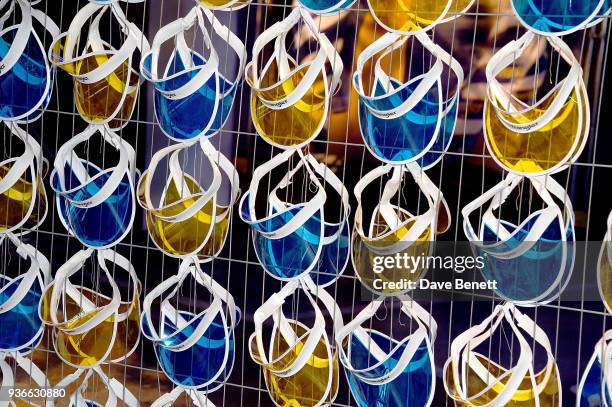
[{"xmin": 0, "ymin": 26, "xmax": 53, "ymax": 121}]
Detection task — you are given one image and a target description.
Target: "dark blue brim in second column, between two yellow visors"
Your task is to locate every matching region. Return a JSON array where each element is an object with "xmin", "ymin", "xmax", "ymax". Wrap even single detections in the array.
[{"xmin": 51, "ymin": 165, "xmax": 135, "ymax": 248}]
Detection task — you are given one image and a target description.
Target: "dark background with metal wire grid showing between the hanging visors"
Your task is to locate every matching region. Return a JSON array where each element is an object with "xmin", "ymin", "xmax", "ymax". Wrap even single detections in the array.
[{"xmin": 3, "ymin": 0, "xmax": 612, "ymax": 406}]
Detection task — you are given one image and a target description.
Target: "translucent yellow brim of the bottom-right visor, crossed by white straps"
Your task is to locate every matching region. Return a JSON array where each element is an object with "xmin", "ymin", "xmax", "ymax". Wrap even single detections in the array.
[{"xmin": 445, "ymin": 353, "xmax": 560, "ymax": 407}]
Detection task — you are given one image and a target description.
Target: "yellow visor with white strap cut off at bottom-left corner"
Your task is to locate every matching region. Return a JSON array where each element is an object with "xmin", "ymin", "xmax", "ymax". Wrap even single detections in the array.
[{"xmin": 0, "ymin": 352, "xmax": 53, "ymax": 407}]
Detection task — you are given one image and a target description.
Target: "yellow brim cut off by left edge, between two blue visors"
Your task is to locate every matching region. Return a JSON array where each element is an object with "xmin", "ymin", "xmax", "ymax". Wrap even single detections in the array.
[{"xmin": 0, "ymin": 162, "xmax": 47, "ymax": 232}]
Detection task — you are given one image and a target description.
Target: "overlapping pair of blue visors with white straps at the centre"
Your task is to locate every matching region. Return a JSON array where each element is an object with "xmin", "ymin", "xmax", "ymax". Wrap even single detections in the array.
[{"xmin": 240, "ymin": 150, "xmax": 350, "ymax": 286}]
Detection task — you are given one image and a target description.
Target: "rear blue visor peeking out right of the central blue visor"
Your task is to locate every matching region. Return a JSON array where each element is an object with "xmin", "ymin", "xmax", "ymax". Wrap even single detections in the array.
[{"xmin": 266, "ymin": 154, "xmax": 351, "ymax": 287}]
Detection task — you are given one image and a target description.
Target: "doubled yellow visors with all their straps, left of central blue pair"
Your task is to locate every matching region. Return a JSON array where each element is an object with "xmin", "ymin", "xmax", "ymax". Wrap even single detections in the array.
[{"xmin": 138, "ymin": 139, "xmax": 240, "ymax": 261}]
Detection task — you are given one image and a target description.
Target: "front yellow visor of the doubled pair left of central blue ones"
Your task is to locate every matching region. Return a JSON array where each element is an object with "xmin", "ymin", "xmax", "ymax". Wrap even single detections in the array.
[{"xmin": 138, "ymin": 141, "xmax": 224, "ymax": 257}]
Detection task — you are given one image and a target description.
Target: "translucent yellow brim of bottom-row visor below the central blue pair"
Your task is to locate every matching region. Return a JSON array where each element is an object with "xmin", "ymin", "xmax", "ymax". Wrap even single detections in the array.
[{"xmin": 264, "ymin": 323, "xmax": 339, "ymax": 407}]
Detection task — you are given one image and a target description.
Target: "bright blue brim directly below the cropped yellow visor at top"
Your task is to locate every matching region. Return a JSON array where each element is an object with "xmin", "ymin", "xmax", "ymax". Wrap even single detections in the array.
[{"xmin": 359, "ymin": 75, "xmax": 442, "ymax": 164}]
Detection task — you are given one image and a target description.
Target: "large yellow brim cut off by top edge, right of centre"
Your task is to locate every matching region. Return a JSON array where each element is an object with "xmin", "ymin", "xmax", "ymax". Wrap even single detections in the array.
[{"xmin": 369, "ymin": 0, "xmax": 454, "ymax": 32}]
